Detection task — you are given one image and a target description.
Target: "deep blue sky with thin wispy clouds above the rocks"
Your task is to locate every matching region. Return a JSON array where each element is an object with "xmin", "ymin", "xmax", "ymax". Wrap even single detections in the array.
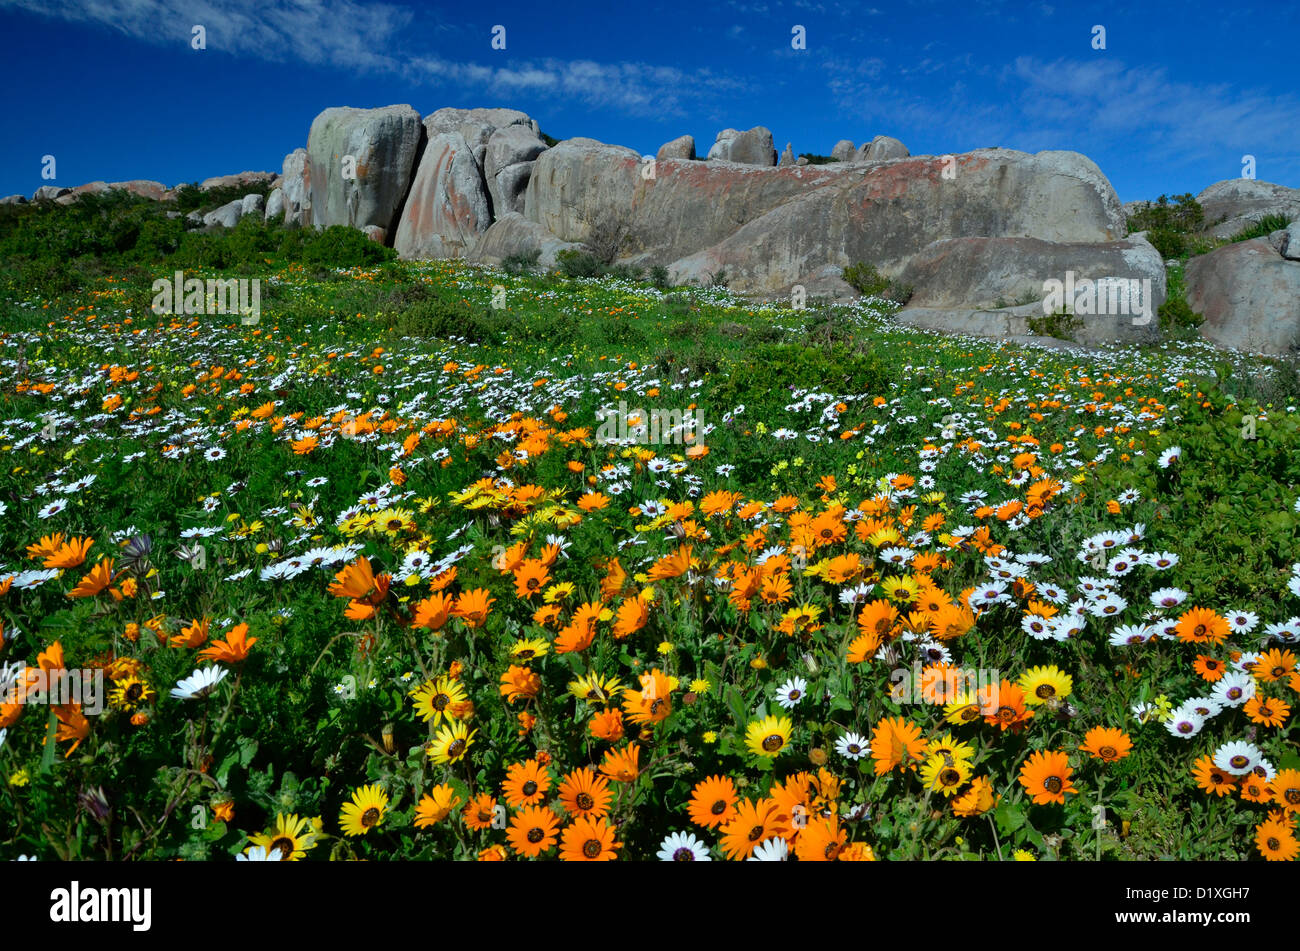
[{"xmin": 0, "ymin": 0, "xmax": 1300, "ymax": 201}]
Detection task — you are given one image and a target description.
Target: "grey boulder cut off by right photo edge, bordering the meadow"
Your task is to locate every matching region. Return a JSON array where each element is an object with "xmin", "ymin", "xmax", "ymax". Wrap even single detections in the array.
[{"xmin": 1186, "ymin": 238, "xmax": 1300, "ymax": 353}]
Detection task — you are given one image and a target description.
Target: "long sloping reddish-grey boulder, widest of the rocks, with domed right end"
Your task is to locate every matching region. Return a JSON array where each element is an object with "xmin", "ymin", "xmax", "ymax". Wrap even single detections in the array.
[{"xmin": 670, "ymin": 149, "xmax": 1126, "ymax": 296}]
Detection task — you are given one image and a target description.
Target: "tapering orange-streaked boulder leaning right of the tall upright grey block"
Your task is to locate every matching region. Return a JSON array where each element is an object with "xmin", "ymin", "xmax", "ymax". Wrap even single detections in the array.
[{"xmin": 393, "ymin": 133, "xmax": 491, "ymax": 259}]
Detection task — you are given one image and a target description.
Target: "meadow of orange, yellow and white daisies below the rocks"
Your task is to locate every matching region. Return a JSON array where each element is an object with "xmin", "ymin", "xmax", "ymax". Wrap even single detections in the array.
[{"xmin": 0, "ymin": 197, "xmax": 1300, "ymax": 861}]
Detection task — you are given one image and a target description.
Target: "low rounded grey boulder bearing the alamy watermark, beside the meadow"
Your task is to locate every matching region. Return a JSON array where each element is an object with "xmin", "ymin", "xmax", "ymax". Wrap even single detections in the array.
[{"xmin": 900, "ymin": 235, "xmax": 1166, "ymax": 344}]
